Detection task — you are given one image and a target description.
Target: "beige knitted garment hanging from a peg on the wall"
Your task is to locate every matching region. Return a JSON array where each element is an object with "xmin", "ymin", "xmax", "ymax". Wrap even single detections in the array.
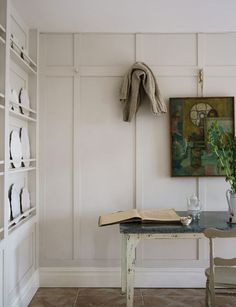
[{"xmin": 120, "ymin": 62, "xmax": 167, "ymax": 122}]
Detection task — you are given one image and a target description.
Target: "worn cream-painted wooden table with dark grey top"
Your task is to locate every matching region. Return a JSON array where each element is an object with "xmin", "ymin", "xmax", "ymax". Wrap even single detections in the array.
[{"xmin": 120, "ymin": 211, "xmax": 233, "ymax": 307}]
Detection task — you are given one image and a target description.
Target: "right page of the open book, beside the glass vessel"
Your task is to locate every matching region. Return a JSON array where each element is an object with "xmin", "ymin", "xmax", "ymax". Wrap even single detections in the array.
[{"xmin": 139, "ymin": 209, "xmax": 180, "ymax": 222}]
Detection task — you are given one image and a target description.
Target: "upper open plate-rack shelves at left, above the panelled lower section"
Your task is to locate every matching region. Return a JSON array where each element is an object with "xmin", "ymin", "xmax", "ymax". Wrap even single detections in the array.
[{"xmin": 0, "ymin": 0, "xmax": 38, "ymax": 239}]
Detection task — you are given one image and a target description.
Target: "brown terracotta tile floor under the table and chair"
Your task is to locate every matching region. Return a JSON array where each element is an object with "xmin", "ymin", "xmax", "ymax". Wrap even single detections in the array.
[{"xmin": 29, "ymin": 288, "xmax": 236, "ymax": 307}]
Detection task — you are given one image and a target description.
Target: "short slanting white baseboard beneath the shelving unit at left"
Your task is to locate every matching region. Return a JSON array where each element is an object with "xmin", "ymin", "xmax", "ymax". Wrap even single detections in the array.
[{"xmin": 9, "ymin": 270, "xmax": 39, "ymax": 307}]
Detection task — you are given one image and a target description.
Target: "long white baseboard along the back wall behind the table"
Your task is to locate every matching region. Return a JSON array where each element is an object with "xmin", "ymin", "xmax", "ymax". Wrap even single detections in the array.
[{"xmin": 39, "ymin": 267, "xmax": 205, "ymax": 288}]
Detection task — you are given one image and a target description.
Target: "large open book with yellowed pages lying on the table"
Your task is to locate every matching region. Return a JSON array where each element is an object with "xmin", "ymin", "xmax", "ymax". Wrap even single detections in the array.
[{"xmin": 98, "ymin": 209, "xmax": 180, "ymax": 226}]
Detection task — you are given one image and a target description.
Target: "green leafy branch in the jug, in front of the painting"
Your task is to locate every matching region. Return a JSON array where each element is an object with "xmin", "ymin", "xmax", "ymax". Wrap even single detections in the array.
[{"xmin": 208, "ymin": 121, "xmax": 236, "ymax": 193}]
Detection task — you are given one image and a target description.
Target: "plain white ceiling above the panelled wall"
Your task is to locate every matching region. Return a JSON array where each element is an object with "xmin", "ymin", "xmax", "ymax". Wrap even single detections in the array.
[{"xmin": 12, "ymin": 0, "xmax": 236, "ymax": 33}]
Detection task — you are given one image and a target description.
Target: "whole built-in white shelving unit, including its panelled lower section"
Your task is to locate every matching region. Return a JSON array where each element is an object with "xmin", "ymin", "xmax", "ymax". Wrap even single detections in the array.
[{"xmin": 0, "ymin": 0, "xmax": 39, "ymax": 307}]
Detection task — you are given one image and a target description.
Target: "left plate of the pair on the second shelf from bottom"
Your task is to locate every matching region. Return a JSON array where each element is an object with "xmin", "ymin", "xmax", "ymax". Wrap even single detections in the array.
[{"xmin": 10, "ymin": 130, "xmax": 22, "ymax": 168}]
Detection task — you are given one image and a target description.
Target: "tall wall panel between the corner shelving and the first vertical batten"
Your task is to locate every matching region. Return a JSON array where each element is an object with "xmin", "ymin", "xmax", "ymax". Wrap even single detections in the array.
[{"xmin": 42, "ymin": 76, "xmax": 73, "ymax": 259}]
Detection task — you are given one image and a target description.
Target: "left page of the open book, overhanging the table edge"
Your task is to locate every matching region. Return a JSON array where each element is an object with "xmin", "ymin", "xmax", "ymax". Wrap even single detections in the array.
[{"xmin": 98, "ymin": 209, "xmax": 141, "ymax": 226}]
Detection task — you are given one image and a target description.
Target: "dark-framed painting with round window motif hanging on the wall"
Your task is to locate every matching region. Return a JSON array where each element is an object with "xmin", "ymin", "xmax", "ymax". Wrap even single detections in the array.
[{"xmin": 170, "ymin": 97, "xmax": 234, "ymax": 177}]
